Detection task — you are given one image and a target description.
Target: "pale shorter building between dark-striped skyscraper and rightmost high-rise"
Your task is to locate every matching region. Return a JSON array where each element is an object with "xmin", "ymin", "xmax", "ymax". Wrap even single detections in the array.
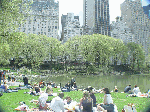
[{"xmin": 111, "ymin": 17, "xmax": 135, "ymax": 44}]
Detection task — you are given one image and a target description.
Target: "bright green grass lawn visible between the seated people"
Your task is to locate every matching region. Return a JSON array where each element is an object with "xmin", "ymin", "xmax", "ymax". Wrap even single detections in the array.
[{"xmin": 0, "ymin": 87, "xmax": 149, "ymax": 112}]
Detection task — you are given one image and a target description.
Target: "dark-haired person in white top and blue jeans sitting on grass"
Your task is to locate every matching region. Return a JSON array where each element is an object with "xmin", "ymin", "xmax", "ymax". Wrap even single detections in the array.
[{"xmin": 97, "ymin": 88, "xmax": 114, "ymax": 112}]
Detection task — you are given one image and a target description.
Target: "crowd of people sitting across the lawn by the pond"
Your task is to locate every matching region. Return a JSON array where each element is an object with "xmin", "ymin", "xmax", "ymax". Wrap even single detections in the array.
[{"xmin": 0, "ymin": 70, "xmax": 146, "ymax": 112}]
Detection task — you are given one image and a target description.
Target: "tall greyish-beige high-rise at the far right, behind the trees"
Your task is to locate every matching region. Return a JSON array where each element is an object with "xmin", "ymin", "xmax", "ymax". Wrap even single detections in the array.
[{"xmin": 121, "ymin": 0, "xmax": 150, "ymax": 54}]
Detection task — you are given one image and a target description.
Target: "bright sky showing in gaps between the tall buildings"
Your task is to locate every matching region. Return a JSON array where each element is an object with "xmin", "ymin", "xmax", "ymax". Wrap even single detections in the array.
[{"xmin": 55, "ymin": 0, "xmax": 149, "ymax": 26}]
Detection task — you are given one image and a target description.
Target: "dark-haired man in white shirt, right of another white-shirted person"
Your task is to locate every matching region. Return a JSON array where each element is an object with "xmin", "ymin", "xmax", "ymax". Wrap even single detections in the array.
[{"xmin": 50, "ymin": 92, "xmax": 64, "ymax": 112}]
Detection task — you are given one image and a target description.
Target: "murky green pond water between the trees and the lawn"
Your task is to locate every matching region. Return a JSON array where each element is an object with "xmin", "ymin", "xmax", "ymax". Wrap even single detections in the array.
[{"xmin": 34, "ymin": 74, "xmax": 150, "ymax": 92}]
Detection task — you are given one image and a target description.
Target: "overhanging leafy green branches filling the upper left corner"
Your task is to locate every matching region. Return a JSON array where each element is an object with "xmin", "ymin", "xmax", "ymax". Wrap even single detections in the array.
[{"xmin": 0, "ymin": 0, "xmax": 32, "ymax": 39}]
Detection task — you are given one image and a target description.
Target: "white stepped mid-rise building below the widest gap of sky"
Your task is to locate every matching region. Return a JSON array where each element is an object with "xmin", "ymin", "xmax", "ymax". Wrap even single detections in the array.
[{"xmin": 61, "ymin": 13, "xmax": 83, "ymax": 43}]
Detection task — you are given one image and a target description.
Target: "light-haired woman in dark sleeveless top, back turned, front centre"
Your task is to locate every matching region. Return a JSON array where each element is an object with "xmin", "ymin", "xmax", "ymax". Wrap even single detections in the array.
[{"xmin": 79, "ymin": 91, "xmax": 93, "ymax": 112}]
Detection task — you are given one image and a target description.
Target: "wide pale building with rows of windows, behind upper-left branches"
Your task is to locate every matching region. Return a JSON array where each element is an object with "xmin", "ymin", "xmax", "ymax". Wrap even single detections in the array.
[{"xmin": 19, "ymin": 0, "xmax": 59, "ymax": 39}]
